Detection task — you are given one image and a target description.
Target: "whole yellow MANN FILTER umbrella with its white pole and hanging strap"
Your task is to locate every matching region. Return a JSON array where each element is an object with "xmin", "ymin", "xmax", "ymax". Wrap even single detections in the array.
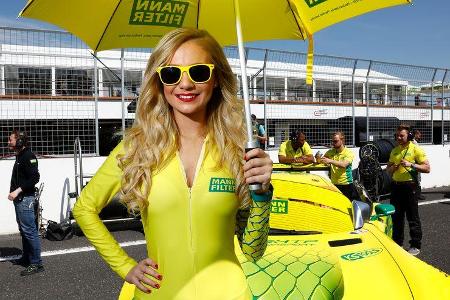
[{"xmin": 19, "ymin": 0, "xmax": 410, "ymax": 157}]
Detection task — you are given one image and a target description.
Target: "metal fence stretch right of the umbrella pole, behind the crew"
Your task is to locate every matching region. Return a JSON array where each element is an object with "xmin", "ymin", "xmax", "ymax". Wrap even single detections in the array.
[{"xmin": 236, "ymin": 49, "xmax": 450, "ymax": 148}]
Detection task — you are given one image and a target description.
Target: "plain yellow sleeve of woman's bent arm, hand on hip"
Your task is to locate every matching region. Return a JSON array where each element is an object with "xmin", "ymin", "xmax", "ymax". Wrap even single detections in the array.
[{"xmin": 72, "ymin": 143, "xmax": 137, "ymax": 278}]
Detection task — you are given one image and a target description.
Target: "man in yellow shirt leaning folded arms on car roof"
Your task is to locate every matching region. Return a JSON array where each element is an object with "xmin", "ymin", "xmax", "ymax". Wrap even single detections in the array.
[{"xmin": 278, "ymin": 130, "xmax": 314, "ymax": 164}]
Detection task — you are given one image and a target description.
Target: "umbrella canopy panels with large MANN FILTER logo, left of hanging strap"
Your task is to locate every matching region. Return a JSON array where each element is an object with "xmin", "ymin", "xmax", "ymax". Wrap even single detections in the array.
[{"xmin": 20, "ymin": 0, "xmax": 304, "ymax": 51}]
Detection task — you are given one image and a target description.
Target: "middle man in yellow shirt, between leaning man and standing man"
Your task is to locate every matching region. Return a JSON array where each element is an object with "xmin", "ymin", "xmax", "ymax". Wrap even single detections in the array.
[{"xmin": 318, "ymin": 131, "xmax": 356, "ymax": 200}]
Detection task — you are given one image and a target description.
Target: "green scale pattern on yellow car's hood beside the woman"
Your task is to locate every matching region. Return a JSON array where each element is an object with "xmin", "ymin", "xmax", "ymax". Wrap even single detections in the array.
[{"xmin": 238, "ymin": 240, "xmax": 344, "ymax": 300}]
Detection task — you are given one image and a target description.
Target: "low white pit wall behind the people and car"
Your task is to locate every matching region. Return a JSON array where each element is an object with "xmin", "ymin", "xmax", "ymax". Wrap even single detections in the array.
[{"xmin": 0, "ymin": 145, "xmax": 450, "ymax": 235}]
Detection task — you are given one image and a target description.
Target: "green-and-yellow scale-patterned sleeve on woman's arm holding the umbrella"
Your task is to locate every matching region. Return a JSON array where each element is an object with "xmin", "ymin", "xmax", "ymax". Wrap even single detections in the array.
[{"xmin": 236, "ymin": 201, "xmax": 272, "ymax": 261}]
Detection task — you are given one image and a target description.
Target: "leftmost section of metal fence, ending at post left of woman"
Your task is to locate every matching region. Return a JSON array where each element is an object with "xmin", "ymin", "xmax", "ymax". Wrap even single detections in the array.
[{"xmin": 0, "ymin": 28, "xmax": 96, "ymax": 156}]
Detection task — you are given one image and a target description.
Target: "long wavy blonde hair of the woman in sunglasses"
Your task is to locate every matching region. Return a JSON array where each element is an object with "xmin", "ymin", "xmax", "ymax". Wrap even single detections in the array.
[{"xmin": 117, "ymin": 28, "xmax": 250, "ymax": 210}]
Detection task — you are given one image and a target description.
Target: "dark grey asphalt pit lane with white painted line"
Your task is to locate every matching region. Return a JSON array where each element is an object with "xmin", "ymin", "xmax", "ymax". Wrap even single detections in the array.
[{"xmin": 0, "ymin": 187, "xmax": 450, "ymax": 300}]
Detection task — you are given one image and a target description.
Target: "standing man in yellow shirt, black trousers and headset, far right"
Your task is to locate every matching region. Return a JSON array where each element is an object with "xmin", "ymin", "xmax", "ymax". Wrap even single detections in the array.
[{"xmin": 387, "ymin": 125, "xmax": 430, "ymax": 255}]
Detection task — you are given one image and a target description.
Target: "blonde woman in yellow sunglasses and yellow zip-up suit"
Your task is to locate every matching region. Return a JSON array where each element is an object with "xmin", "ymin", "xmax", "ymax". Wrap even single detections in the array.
[{"xmin": 73, "ymin": 29, "xmax": 272, "ymax": 299}]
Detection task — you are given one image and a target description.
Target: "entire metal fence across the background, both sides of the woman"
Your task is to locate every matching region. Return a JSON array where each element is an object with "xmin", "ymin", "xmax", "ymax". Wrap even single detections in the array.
[{"xmin": 0, "ymin": 28, "xmax": 450, "ymax": 157}]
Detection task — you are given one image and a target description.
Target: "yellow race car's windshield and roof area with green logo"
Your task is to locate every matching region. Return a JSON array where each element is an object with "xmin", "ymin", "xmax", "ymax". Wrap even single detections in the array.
[{"xmin": 270, "ymin": 172, "xmax": 353, "ymax": 234}]
